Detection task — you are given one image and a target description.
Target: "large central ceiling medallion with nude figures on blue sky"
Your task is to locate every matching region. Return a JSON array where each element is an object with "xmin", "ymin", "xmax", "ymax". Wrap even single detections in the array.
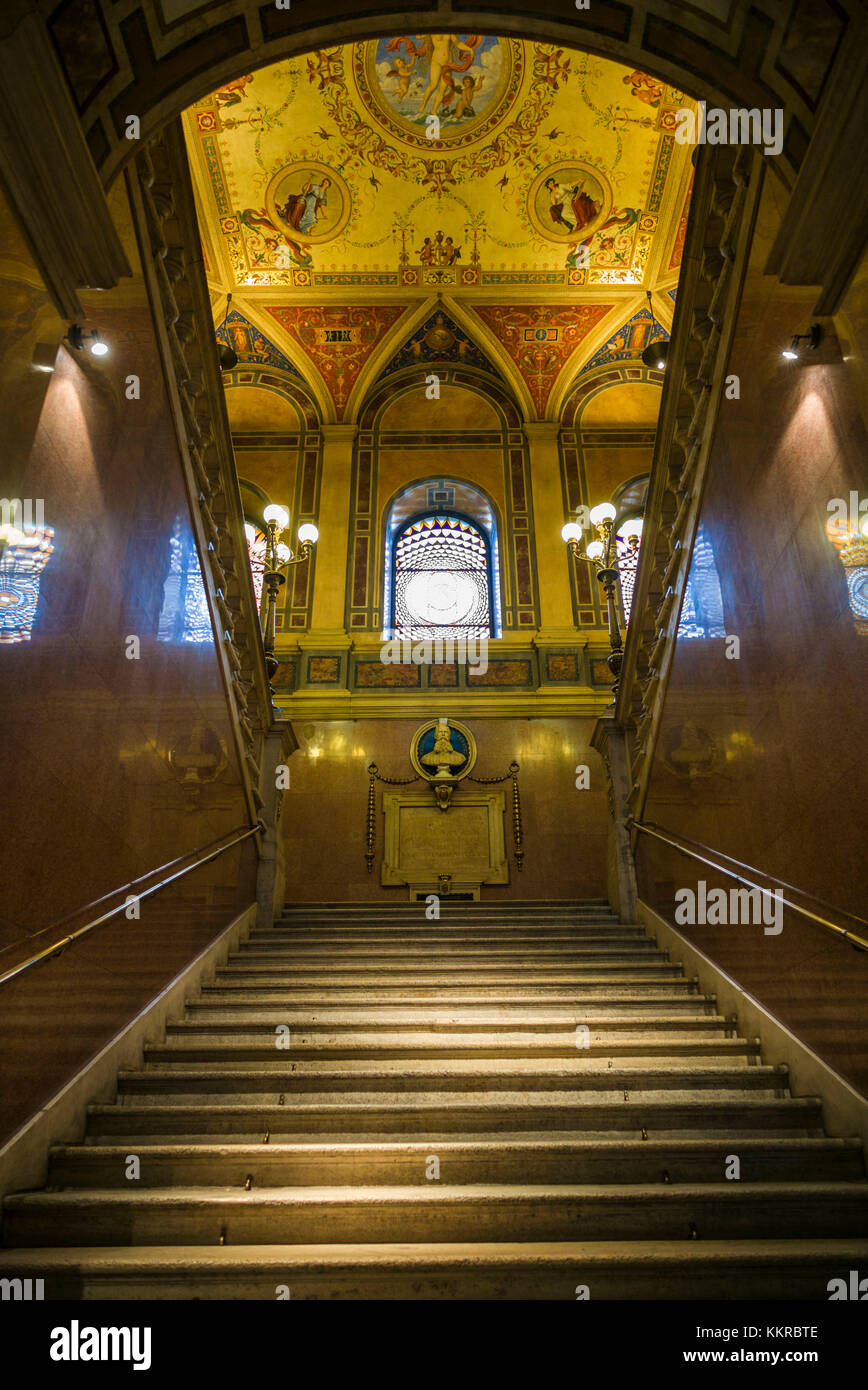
[{"xmin": 353, "ymin": 33, "xmax": 523, "ymax": 150}]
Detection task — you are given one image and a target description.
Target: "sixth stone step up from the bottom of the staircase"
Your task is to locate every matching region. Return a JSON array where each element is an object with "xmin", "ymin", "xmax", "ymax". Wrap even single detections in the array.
[{"xmin": 145, "ymin": 1024, "xmax": 760, "ymax": 1066}]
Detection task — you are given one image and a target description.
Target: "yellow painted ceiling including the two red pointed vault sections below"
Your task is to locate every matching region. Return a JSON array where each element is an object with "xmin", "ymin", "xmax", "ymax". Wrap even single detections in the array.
[{"xmin": 184, "ymin": 35, "xmax": 691, "ymax": 420}]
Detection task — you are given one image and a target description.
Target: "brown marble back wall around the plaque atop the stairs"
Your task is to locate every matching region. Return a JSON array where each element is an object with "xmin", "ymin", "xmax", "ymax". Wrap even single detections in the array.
[{"xmin": 282, "ymin": 708, "xmax": 606, "ymax": 902}]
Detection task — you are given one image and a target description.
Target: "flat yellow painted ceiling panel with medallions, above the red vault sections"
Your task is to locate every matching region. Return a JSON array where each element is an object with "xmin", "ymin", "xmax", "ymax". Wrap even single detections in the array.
[{"xmin": 185, "ymin": 35, "xmax": 690, "ymax": 300}]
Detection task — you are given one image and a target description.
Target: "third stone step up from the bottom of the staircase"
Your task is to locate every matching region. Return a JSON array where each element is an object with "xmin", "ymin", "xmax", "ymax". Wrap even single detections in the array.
[{"xmin": 47, "ymin": 1136, "xmax": 865, "ymax": 1190}]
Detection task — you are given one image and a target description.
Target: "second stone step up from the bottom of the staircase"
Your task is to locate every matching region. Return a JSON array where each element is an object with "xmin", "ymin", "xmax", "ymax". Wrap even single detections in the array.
[{"xmin": 4, "ymin": 1179, "xmax": 868, "ymax": 1247}]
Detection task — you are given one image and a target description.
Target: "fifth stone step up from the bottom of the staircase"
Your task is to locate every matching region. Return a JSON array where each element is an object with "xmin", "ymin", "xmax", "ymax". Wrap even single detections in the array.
[{"xmin": 118, "ymin": 1054, "xmax": 789, "ymax": 1101}]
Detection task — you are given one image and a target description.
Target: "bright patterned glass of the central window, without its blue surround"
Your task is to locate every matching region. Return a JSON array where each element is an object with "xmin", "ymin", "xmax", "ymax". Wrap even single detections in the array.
[{"xmin": 394, "ymin": 513, "xmax": 491, "ymax": 642}]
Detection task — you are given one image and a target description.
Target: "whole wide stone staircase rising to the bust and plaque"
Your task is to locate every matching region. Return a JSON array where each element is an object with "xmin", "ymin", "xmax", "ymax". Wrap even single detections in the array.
[{"xmin": 0, "ymin": 902, "xmax": 868, "ymax": 1300}]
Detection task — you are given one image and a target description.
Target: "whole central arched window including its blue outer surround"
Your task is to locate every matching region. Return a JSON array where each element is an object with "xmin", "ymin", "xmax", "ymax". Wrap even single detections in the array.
[{"xmin": 384, "ymin": 480, "xmax": 501, "ymax": 642}]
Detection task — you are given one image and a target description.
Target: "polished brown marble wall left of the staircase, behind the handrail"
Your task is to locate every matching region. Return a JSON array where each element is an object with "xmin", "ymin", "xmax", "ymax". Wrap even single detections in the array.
[{"xmin": 0, "ymin": 185, "xmax": 255, "ymax": 1138}]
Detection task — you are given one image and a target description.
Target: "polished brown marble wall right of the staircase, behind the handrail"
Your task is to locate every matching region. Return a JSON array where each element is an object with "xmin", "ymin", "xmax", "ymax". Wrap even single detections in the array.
[{"xmin": 641, "ymin": 165, "xmax": 868, "ymax": 1091}]
